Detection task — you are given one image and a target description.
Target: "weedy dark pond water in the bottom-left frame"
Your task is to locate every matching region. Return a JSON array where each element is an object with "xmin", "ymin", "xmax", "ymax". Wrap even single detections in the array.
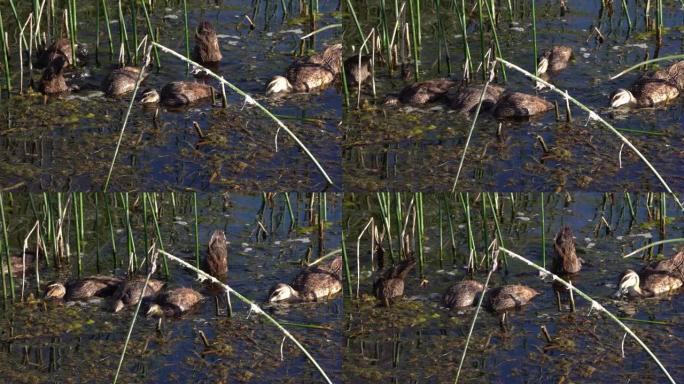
[{"xmin": 0, "ymin": 193, "xmax": 342, "ymax": 383}]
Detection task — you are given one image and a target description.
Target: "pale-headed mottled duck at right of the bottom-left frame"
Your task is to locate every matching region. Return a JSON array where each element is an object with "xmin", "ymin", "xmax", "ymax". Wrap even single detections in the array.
[{"xmin": 268, "ymin": 258, "xmax": 342, "ymax": 303}]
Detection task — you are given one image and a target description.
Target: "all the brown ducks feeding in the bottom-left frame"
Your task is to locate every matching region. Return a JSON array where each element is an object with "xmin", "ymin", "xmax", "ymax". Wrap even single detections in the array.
[{"xmin": 30, "ymin": 230, "xmax": 342, "ymax": 316}]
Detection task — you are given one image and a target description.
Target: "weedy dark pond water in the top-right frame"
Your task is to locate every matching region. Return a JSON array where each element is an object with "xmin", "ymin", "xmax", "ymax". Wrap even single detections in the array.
[{"xmin": 342, "ymin": 1, "xmax": 684, "ymax": 191}]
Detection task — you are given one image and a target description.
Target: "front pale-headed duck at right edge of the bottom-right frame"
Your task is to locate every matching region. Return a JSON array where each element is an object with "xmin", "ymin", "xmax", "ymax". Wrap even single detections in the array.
[{"xmin": 614, "ymin": 269, "xmax": 682, "ymax": 298}]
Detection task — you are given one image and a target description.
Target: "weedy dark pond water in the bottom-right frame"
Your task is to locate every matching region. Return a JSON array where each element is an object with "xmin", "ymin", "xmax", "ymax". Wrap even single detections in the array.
[{"xmin": 343, "ymin": 193, "xmax": 684, "ymax": 383}]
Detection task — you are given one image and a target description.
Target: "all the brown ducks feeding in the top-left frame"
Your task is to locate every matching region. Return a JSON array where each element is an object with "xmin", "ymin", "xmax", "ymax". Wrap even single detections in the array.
[{"xmin": 36, "ymin": 21, "xmax": 342, "ymax": 107}]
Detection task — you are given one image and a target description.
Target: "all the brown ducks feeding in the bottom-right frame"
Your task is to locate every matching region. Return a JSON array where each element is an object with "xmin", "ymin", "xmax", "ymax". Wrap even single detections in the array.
[{"xmin": 373, "ymin": 227, "xmax": 684, "ymax": 312}]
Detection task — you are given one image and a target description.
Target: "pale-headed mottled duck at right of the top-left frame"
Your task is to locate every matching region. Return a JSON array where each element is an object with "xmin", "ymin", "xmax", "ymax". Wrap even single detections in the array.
[{"xmin": 266, "ymin": 44, "xmax": 342, "ymax": 95}]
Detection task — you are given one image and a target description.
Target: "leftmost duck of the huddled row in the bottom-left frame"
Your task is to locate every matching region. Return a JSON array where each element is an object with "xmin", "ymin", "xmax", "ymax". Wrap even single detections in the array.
[{"xmin": 45, "ymin": 275, "xmax": 122, "ymax": 301}]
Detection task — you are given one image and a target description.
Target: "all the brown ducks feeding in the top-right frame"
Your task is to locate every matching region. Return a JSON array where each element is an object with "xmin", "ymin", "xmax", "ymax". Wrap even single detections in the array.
[{"xmin": 345, "ymin": 45, "xmax": 684, "ymax": 118}]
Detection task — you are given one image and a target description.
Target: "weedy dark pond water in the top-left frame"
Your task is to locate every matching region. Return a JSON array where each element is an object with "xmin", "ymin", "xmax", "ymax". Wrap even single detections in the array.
[{"xmin": 0, "ymin": 1, "xmax": 341, "ymax": 191}]
